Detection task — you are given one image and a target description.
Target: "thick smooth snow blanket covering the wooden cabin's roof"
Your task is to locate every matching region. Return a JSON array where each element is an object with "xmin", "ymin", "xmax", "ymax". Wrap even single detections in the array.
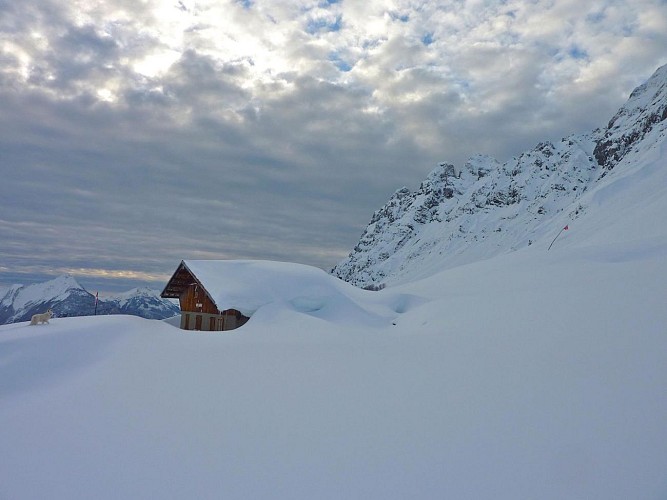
[{"xmin": 183, "ymin": 260, "xmax": 352, "ymax": 316}]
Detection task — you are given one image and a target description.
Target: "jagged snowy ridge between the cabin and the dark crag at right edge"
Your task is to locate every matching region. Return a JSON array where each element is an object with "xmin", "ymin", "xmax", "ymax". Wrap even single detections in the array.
[{"xmin": 332, "ymin": 135, "xmax": 599, "ymax": 288}]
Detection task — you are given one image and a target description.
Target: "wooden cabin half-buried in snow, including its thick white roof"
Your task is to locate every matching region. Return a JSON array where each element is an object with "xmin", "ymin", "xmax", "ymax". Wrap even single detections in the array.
[{"xmin": 161, "ymin": 260, "xmax": 344, "ymax": 331}]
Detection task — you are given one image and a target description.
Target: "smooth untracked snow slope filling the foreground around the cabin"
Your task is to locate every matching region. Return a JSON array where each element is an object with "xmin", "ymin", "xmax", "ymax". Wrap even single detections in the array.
[{"xmin": 0, "ymin": 134, "xmax": 667, "ymax": 500}]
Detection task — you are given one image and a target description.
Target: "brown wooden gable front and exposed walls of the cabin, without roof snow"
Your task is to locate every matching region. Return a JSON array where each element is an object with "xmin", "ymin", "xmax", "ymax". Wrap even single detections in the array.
[{"xmin": 161, "ymin": 262, "xmax": 250, "ymax": 331}]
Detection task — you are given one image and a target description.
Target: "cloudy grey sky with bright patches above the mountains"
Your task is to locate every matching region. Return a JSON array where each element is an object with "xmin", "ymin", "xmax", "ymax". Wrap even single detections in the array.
[{"xmin": 0, "ymin": 0, "xmax": 667, "ymax": 291}]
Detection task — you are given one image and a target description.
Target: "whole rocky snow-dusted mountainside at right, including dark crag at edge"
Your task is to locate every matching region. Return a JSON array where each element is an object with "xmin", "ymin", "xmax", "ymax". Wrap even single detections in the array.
[{"xmin": 331, "ymin": 65, "xmax": 667, "ymax": 289}]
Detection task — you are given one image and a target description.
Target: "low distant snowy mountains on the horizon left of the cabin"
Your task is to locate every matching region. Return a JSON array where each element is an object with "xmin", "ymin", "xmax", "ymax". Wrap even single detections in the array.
[{"xmin": 0, "ymin": 275, "xmax": 180, "ymax": 324}]
